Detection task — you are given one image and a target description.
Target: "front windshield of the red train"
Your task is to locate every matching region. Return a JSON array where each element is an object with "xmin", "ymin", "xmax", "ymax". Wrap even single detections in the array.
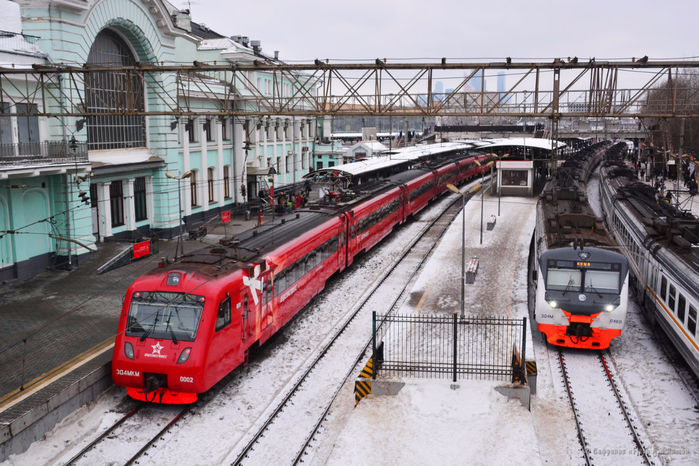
[{"xmin": 126, "ymin": 292, "xmax": 204, "ymax": 341}]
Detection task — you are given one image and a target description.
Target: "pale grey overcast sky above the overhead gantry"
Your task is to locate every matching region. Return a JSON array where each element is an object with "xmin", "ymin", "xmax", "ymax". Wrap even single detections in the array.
[{"xmin": 191, "ymin": 0, "xmax": 699, "ymax": 61}]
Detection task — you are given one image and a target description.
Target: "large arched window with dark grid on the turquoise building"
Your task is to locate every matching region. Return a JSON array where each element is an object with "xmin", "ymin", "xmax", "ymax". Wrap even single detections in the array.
[{"xmin": 85, "ymin": 29, "xmax": 146, "ymax": 150}]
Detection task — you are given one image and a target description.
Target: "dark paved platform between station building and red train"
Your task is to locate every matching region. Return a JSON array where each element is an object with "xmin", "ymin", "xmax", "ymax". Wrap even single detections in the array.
[{"xmin": 0, "ymin": 213, "xmax": 271, "ymax": 462}]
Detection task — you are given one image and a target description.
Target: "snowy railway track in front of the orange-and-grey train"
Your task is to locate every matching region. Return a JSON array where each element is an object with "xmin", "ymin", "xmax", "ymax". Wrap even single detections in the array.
[{"xmin": 557, "ymin": 350, "xmax": 659, "ymax": 466}]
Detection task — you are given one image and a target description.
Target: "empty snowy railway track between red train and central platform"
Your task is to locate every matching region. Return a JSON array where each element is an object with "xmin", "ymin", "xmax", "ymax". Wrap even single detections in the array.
[{"xmin": 225, "ymin": 183, "xmax": 484, "ymax": 465}]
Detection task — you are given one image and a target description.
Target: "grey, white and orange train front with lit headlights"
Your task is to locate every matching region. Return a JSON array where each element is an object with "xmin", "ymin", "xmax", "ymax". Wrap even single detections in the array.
[{"xmin": 535, "ymin": 248, "xmax": 629, "ymax": 349}]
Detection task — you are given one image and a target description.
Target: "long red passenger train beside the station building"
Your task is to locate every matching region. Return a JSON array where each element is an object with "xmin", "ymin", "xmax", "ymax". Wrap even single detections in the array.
[{"xmin": 112, "ymin": 155, "xmax": 490, "ymax": 404}]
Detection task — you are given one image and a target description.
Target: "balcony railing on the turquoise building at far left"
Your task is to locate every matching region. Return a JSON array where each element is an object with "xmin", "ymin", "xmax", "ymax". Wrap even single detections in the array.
[{"xmin": 0, "ymin": 141, "xmax": 89, "ymax": 170}]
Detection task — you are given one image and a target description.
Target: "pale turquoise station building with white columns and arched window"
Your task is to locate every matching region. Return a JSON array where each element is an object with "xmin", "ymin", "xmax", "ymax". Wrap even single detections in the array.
[{"xmin": 0, "ymin": 0, "xmax": 319, "ymax": 283}]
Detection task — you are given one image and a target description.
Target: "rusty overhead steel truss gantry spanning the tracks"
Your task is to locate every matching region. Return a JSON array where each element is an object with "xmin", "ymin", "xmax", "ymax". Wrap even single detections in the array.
[{"xmin": 0, "ymin": 57, "xmax": 699, "ymax": 122}]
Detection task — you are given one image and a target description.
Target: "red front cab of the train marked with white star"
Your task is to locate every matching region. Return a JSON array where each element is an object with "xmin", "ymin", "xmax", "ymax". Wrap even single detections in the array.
[{"xmin": 112, "ymin": 269, "xmax": 240, "ymax": 404}]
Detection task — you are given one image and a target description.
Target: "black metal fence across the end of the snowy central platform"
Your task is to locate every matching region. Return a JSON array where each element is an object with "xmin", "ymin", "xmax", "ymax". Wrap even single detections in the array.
[{"xmin": 372, "ymin": 313, "xmax": 527, "ymax": 382}]
